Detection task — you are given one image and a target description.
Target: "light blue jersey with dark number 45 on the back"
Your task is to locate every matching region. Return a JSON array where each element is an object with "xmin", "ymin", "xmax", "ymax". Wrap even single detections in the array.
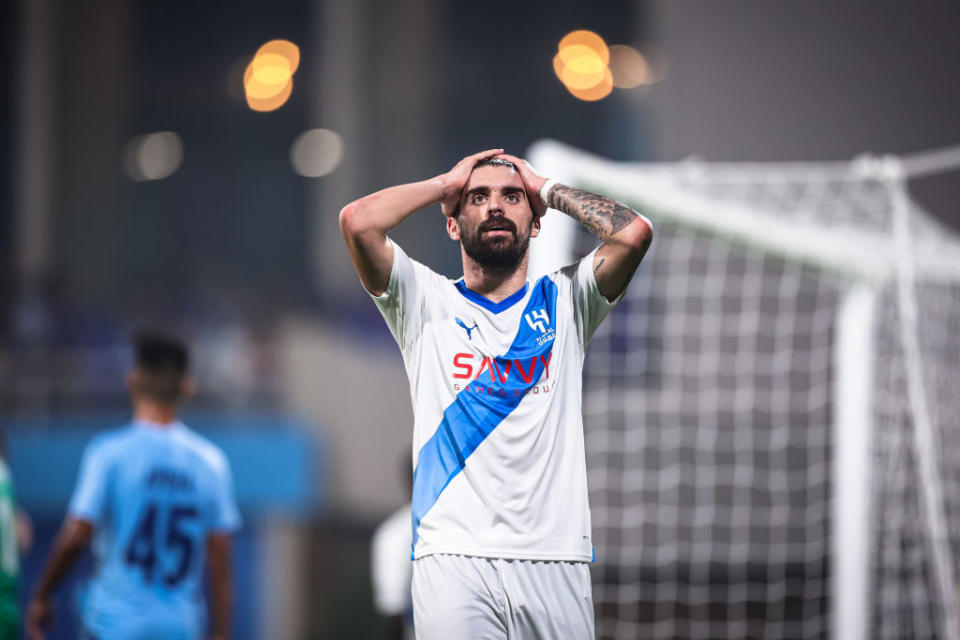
[{"xmin": 70, "ymin": 422, "xmax": 240, "ymax": 640}]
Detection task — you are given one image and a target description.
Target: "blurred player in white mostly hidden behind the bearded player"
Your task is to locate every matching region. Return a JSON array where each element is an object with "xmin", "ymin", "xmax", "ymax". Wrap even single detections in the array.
[{"xmin": 370, "ymin": 453, "xmax": 414, "ymax": 640}]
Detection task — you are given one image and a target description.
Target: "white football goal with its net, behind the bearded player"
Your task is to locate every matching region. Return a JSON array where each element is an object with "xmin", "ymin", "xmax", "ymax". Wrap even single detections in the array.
[{"xmin": 528, "ymin": 141, "xmax": 960, "ymax": 640}]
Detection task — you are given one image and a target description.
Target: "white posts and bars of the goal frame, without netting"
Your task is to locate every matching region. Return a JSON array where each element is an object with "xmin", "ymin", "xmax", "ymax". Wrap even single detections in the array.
[{"xmin": 527, "ymin": 140, "xmax": 960, "ymax": 640}]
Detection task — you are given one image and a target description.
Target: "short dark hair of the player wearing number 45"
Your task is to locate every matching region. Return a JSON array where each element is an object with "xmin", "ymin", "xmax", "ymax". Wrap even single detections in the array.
[{"xmin": 133, "ymin": 329, "xmax": 190, "ymax": 403}]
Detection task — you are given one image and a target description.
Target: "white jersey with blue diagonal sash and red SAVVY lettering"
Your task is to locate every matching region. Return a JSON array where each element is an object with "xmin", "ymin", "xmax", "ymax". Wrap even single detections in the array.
[{"xmin": 373, "ymin": 239, "xmax": 615, "ymax": 561}]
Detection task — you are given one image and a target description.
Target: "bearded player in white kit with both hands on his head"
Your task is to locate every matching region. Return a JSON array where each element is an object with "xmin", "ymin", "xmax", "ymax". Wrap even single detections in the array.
[{"xmin": 340, "ymin": 149, "xmax": 652, "ymax": 640}]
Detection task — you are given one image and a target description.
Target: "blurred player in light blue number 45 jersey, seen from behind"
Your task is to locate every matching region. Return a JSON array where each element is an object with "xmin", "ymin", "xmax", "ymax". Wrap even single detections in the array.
[{"xmin": 27, "ymin": 332, "xmax": 240, "ymax": 640}]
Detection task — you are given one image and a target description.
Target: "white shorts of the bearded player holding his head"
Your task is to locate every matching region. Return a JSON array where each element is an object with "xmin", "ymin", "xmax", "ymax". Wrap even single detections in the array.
[{"xmin": 411, "ymin": 554, "xmax": 594, "ymax": 640}]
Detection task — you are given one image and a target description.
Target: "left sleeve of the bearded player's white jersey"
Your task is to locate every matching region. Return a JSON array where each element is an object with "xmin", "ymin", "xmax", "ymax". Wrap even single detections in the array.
[{"xmin": 370, "ymin": 240, "xmax": 428, "ymax": 349}]
